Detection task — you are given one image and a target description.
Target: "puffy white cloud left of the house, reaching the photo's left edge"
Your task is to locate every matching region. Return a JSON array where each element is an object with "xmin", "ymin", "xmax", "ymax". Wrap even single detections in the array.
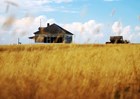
[{"xmin": 0, "ymin": 16, "xmax": 55, "ymax": 43}]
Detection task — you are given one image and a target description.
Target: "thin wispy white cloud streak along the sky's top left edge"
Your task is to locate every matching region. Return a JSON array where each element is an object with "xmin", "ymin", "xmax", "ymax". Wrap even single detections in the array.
[{"xmin": 0, "ymin": 0, "xmax": 76, "ymax": 16}]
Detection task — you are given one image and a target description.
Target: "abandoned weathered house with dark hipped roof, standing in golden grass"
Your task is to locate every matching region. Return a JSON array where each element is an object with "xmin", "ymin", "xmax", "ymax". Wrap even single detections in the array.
[{"xmin": 29, "ymin": 23, "xmax": 73, "ymax": 43}]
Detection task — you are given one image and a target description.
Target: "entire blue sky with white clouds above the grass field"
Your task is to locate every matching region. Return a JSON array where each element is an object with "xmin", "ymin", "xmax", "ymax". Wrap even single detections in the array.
[{"xmin": 0, "ymin": 0, "xmax": 140, "ymax": 44}]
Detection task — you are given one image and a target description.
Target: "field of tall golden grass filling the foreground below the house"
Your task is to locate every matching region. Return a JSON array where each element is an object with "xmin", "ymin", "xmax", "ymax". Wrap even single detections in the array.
[{"xmin": 0, "ymin": 44, "xmax": 140, "ymax": 99}]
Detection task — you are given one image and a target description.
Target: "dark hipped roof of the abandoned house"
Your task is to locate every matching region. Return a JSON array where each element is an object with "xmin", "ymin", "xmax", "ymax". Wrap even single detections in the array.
[{"xmin": 34, "ymin": 24, "xmax": 73, "ymax": 35}]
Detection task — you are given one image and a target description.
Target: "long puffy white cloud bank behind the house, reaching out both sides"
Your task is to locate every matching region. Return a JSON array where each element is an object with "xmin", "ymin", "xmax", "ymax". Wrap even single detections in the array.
[{"xmin": 0, "ymin": 16, "xmax": 103, "ymax": 43}]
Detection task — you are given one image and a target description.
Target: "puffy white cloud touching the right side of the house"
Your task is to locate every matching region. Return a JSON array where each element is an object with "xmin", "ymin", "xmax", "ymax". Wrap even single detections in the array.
[{"xmin": 63, "ymin": 20, "xmax": 104, "ymax": 43}]
